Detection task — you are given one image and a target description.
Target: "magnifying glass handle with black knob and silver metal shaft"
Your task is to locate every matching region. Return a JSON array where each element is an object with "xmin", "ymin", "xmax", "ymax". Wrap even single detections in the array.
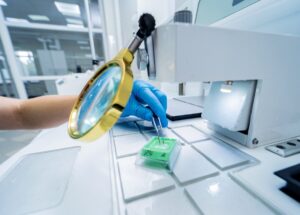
[{"xmin": 128, "ymin": 13, "xmax": 155, "ymax": 54}]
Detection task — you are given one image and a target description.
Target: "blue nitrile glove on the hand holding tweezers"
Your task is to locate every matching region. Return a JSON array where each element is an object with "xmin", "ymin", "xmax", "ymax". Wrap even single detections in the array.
[{"xmin": 121, "ymin": 80, "xmax": 168, "ymax": 127}]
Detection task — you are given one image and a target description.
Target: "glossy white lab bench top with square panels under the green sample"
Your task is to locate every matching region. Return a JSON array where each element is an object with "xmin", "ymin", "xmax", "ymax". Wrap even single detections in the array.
[{"xmin": 0, "ymin": 119, "xmax": 300, "ymax": 215}]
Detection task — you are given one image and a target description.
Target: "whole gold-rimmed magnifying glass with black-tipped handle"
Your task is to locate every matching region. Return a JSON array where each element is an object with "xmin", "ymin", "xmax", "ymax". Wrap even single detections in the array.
[{"xmin": 68, "ymin": 13, "xmax": 155, "ymax": 141}]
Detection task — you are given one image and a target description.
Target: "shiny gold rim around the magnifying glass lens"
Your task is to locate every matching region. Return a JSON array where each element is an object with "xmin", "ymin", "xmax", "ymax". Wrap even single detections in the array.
[{"xmin": 68, "ymin": 55, "xmax": 133, "ymax": 142}]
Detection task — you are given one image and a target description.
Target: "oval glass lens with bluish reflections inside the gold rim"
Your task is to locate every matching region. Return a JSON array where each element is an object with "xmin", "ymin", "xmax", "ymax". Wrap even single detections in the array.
[{"xmin": 77, "ymin": 66, "xmax": 122, "ymax": 135}]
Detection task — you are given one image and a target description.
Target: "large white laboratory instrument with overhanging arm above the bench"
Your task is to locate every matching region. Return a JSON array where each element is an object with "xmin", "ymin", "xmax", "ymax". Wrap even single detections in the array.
[{"xmin": 154, "ymin": 24, "xmax": 300, "ymax": 147}]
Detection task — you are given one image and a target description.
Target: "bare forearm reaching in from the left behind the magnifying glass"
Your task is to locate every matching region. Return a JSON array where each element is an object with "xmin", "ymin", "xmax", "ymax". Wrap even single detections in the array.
[{"xmin": 0, "ymin": 96, "xmax": 77, "ymax": 129}]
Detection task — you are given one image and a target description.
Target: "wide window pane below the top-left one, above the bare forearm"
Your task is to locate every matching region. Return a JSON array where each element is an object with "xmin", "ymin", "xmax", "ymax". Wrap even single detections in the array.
[{"xmin": 9, "ymin": 28, "xmax": 92, "ymax": 76}]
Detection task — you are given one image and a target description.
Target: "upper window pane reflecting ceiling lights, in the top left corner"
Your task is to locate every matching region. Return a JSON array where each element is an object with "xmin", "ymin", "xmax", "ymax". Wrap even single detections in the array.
[{"xmin": 3, "ymin": 0, "xmax": 87, "ymax": 27}]
